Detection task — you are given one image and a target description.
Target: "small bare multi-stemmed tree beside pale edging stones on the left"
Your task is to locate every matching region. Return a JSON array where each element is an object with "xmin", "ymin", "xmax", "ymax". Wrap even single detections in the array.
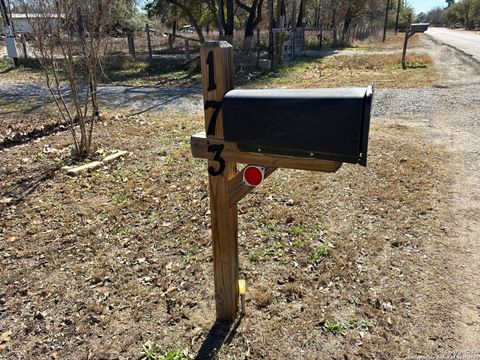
[{"xmin": 17, "ymin": 0, "xmax": 113, "ymax": 158}]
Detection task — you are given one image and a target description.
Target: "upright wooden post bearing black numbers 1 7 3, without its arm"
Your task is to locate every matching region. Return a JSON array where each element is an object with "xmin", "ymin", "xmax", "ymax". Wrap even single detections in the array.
[{"xmin": 200, "ymin": 41, "xmax": 239, "ymax": 321}]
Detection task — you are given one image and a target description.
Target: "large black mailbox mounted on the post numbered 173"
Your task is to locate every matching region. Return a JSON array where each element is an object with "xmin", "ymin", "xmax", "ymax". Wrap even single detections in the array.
[{"xmin": 222, "ymin": 86, "xmax": 373, "ymax": 166}]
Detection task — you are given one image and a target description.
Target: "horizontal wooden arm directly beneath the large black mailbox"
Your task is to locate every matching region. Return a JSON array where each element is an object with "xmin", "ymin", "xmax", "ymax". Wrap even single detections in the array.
[{"xmin": 190, "ymin": 133, "xmax": 342, "ymax": 173}]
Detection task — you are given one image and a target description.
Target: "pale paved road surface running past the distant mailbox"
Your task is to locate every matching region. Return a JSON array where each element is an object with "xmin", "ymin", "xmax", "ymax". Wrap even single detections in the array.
[{"xmin": 426, "ymin": 28, "xmax": 480, "ymax": 62}]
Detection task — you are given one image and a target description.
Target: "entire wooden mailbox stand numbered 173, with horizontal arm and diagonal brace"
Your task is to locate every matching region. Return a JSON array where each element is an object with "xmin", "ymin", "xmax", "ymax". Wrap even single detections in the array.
[{"xmin": 191, "ymin": 41, "xmax": 368, "ymax": 321}]
